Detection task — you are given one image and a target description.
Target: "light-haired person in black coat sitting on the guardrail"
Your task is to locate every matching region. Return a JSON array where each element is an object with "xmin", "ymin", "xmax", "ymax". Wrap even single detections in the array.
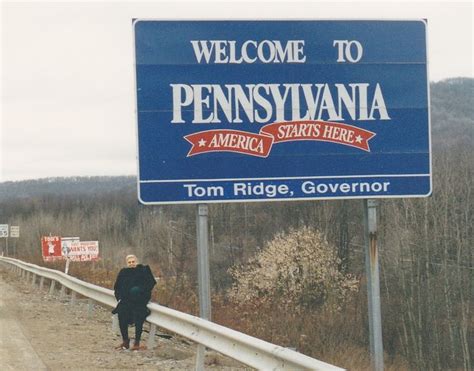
[{"xmin": 112, "ymin": 255, "xmax": 156, "ymax": 350}]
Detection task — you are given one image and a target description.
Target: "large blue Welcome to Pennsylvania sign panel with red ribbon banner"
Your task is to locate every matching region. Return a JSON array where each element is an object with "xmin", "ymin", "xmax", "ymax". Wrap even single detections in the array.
[{"xmin": 134, "ymin": 20, "xmax": 431, "ymax": 204}]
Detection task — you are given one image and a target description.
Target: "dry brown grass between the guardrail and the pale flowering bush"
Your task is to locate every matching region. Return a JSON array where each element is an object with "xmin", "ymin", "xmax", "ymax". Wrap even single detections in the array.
[{"xmin": 213, "ymin": 298, "xmax": 409, "ymax": 371}]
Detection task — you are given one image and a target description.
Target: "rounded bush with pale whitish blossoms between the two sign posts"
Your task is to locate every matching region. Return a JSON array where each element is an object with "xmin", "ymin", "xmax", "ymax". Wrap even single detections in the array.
[{"xmin": 229, "ymin": 227, "xmax": 359, "ymax": 309}]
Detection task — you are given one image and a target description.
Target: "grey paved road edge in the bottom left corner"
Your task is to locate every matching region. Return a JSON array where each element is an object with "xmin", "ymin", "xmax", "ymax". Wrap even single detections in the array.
[{"xmin": 0, "ymin": 281, "xmax": 47, "ymax": 371}]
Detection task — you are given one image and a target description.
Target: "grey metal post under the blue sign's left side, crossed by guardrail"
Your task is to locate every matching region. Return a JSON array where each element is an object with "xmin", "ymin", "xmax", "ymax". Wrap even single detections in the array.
[{"xmin": 196, "ymin": 204, "xmax": 211, "ymax": 370}]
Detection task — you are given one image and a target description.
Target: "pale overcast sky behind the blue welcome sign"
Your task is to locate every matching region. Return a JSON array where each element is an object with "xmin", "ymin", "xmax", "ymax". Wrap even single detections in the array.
[{"xmin": 0, "ymin": 0, "xmax": 473, "ymax": 181}]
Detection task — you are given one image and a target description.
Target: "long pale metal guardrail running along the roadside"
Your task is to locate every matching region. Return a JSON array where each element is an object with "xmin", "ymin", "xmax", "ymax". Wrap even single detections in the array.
[{"xmin": 0, "ymin": 257, "xmax": 343, "ymax": 371}]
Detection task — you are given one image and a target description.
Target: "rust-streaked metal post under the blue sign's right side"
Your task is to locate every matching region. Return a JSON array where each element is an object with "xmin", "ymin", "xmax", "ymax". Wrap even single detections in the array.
[{"xmin": 364, "ymin": 200, "xmax": 383, "ymax": 371}]
